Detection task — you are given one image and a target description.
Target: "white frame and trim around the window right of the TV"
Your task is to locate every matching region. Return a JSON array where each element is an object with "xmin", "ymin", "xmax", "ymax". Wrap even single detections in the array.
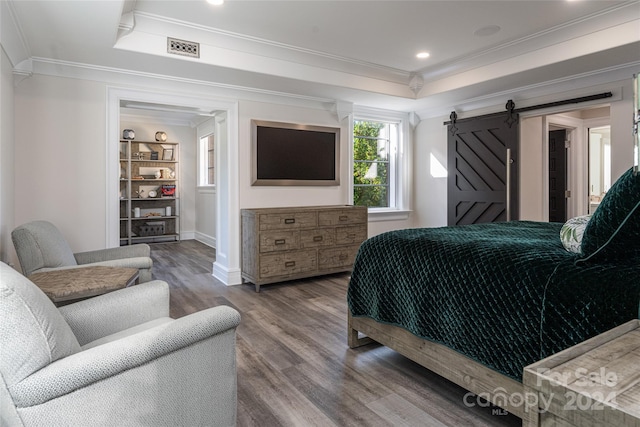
[{"xmin": 349, "ymin": 106, "xmax": 411, "ymax": 221}]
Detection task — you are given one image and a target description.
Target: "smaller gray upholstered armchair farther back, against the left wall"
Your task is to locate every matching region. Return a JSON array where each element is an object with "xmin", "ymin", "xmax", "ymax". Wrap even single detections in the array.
[{"xmin": 11, "ymin": 221, "xmax": 153, "ymax": 283}]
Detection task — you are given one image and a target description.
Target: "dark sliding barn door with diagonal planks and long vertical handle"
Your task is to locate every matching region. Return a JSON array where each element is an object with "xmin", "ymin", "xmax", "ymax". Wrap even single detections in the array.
[{"xmin": 447, "ymin": 112, "xmax": 518, "ymax": 225}]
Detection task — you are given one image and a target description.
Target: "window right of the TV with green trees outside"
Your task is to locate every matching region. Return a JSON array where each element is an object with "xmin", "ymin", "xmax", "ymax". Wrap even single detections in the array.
[{"xmin": 353, "ymin": 110, "xmax": 409, "ymax": 219}]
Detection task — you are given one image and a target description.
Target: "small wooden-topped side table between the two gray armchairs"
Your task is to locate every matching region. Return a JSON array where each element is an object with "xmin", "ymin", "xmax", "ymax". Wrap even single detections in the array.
[{"xmin": 29, "ymin": 266, "xmax": 138, "ymax": 305}]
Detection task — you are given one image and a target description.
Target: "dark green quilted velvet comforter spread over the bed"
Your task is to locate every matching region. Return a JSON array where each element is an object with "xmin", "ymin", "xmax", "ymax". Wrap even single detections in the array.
[{"xmin": 347, "ymin": 221, "xmax": 640, "ymax": 381}]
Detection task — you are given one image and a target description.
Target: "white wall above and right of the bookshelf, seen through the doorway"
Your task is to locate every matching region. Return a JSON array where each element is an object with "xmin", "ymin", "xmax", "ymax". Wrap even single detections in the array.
[{"xmin": 120, "ymin": 116, "xmax": 197, "ymax": 240}]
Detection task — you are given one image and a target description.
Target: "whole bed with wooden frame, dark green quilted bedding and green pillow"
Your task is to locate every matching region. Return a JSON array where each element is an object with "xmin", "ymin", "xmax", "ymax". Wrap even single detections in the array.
[{"xmin": 347, "ymin": 170, "xmax": 640, "ymax": 419}]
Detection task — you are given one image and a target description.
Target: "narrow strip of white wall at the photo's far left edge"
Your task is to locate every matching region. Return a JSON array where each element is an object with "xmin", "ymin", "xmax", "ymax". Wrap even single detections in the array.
[{"xmin": 0, "ymin": 49, "xmax": 16, "ymax": 263}]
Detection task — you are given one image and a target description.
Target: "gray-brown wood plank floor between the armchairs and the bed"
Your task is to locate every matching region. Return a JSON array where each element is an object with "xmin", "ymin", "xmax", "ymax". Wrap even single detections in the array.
[{"xmin": 151, "ymin": 240, "xmax": 521, "ymax": 427}]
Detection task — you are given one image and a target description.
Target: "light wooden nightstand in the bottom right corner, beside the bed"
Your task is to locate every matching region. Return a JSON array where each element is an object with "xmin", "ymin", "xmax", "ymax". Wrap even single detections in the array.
[{"xmin": 523, "ymin": 320, "xmax": 640, "ymax": 427}]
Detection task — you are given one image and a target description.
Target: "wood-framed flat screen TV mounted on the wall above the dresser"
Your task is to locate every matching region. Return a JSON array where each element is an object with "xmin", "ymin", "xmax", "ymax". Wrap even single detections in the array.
[{"xmin": 251, "ymin": 120, "xmax": 340, "ymax": 185}]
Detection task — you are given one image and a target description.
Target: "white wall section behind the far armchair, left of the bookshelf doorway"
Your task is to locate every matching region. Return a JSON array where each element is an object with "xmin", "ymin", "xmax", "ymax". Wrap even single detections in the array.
[{"xmin": 12, "ymin": 75, "xmax": 106, "ymax": 264}]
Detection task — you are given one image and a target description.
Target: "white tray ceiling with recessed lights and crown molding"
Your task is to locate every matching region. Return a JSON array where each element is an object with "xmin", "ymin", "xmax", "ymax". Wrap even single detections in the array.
[{"xmin": 2, "ymin": 0, "xmax": 640, "ymax": 117}]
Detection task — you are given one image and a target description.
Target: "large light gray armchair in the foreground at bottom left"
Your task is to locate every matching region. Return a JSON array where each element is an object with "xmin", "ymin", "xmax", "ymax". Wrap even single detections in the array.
[{"xmin": 0, "ymin": 263, "xmax": 240, "ymax": 426}]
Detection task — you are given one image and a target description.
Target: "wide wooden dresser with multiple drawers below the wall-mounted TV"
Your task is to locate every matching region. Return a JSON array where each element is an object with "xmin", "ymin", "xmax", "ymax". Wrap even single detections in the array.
[{"xmin": 241, "ymin": 205, "xmax": 368, "ymax": 292}]
